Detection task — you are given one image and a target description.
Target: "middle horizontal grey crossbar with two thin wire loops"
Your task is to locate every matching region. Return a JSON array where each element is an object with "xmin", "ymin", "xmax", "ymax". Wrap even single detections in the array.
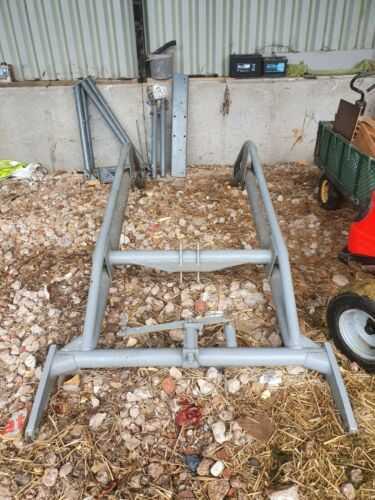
[{"xmin": 108, "ymin": 250, "xmax": 272, "ymax": 272}]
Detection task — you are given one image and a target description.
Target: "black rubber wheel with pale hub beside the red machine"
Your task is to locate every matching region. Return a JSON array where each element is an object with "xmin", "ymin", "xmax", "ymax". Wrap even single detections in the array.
[{"xmin": 327, "ymin": 291, "xmax": 375, "ymax": 373}]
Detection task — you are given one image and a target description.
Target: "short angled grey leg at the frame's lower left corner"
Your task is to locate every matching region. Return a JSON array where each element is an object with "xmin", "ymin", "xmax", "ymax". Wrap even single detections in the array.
[{"xmin": 25, "ymin": 345, "xmax": 57, "ymax": 439}]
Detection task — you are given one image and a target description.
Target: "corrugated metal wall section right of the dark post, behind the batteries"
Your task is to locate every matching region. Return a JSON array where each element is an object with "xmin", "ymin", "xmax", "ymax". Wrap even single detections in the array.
[{"xmin": 146, "ymin": 0, "xmax": 375, "ymax": 75}]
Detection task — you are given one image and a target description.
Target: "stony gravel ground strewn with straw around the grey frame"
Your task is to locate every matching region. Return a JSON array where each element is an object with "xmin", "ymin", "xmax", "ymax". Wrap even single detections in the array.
[{"xmin": 0, "ymin": 163, "xmax": 375, "ymax": 500}]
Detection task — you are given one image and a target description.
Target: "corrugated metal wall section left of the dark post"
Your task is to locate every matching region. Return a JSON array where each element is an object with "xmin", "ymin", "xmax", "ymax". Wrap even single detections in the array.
[{"xmin": 0, "ymin": 0, "xmax": 138, "ymax": 80}]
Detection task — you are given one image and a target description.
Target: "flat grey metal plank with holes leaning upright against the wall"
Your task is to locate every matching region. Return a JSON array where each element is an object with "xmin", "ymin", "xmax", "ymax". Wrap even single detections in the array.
[{"xmin": 171, "ymin": 73, "xmax": 189, "ymax": 177}]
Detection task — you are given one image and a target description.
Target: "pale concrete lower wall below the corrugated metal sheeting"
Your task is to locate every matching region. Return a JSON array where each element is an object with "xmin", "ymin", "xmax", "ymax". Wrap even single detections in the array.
[{"xmin": 0, "ymin": 77, "xmax": 375, "ymax": 170}]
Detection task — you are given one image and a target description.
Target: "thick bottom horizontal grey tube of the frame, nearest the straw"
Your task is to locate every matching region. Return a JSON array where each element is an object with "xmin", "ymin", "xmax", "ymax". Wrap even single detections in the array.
[{"xmin": 51, "ymin": 347, "xmax": 331, "ymax": 376}]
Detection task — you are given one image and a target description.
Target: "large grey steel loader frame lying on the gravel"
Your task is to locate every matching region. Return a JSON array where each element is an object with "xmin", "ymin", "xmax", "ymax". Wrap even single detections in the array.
[{"xmin": 26, "ymin": 141, "xmax": 357, "ymax": 438}]
